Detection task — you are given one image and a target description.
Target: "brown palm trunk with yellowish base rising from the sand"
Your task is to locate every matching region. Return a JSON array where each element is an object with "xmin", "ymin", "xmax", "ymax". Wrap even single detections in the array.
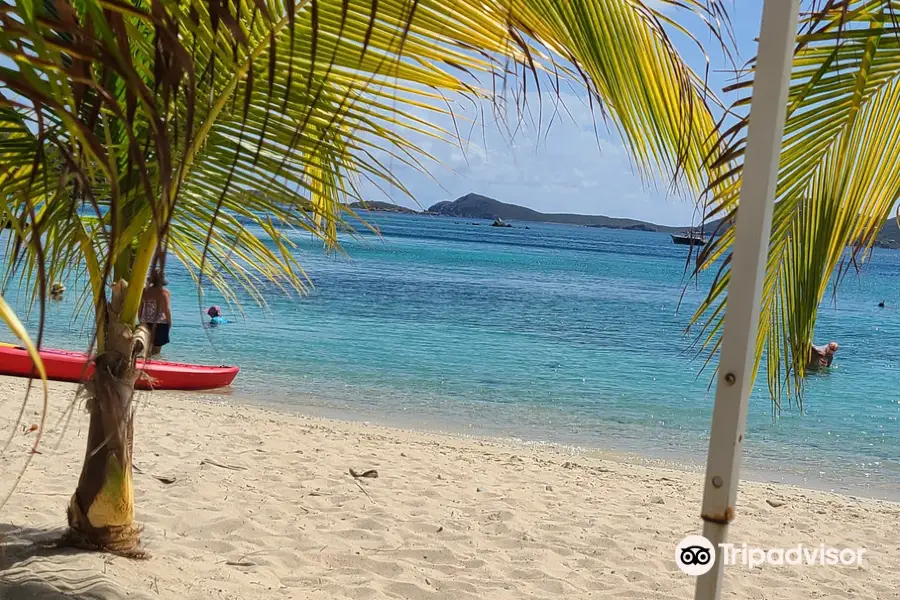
[{"xmin": 65, "ymin": 280, "xmax": 150, "ymax": 558}]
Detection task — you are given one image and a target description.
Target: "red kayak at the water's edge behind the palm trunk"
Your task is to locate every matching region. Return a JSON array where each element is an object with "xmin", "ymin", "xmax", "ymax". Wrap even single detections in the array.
[{"xmin": 0, "ymin": 343, "xmax": 240, "ymax": 390}]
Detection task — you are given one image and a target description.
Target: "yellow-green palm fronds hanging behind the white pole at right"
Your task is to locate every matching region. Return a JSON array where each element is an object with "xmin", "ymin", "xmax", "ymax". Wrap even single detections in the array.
[{"xmin": 693, "ymin": 0, "xmax": 900, "ymax": 410}]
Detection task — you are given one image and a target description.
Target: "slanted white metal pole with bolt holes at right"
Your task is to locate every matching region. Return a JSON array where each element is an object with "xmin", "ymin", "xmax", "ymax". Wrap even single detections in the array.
[{"xmin": 694, "ymin": 0, "xmax": 800, "ymax": 600}]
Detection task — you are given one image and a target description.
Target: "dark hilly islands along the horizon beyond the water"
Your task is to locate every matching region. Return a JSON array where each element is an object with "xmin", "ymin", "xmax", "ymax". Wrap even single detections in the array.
[{"xmin": 350, "ymin": 193, "xmax": 900, "ymax": 249}]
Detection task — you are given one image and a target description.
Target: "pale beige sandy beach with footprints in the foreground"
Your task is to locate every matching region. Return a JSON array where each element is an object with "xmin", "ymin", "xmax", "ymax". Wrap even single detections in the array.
[{"xmin": 0, "ymin": 378, "xmax": 900, "ymax": 600}]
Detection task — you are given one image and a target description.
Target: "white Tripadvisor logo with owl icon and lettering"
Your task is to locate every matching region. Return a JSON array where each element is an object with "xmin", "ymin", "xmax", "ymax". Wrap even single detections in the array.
[{"xmin": 675, "ymin": 535, "xmax": 866, "ymax": 577}]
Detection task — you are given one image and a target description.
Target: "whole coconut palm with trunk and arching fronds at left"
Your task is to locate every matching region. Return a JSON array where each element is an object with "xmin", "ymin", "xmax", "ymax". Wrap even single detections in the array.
[{"xmin": 0, "ymin": 0, "xmax": 724, "ymax": 556}]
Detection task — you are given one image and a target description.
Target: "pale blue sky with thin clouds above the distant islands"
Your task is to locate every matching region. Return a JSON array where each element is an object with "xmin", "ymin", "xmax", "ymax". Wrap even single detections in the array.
[{"xmin": 362, "ymin": 0, "xmax": 762, "ymax": 226}]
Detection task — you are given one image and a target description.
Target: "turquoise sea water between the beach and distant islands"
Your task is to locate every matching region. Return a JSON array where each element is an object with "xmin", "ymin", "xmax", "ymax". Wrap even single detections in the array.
[{"xmin": 6, "ymin": 215, "xmax": 900, "ymax": 496}]
